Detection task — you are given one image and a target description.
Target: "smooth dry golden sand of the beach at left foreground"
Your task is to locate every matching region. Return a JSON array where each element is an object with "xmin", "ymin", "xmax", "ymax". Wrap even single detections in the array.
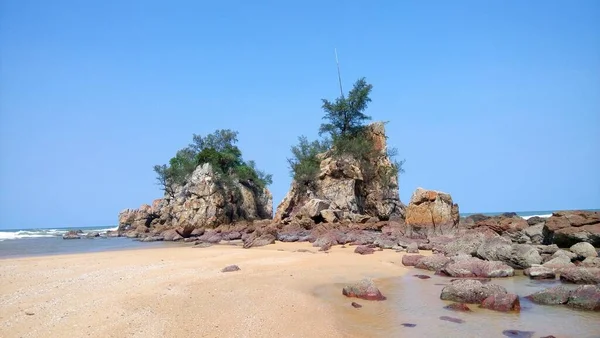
[{"xmin": 0, "ymin": 243, "xmax": 422, "ymax": 337}]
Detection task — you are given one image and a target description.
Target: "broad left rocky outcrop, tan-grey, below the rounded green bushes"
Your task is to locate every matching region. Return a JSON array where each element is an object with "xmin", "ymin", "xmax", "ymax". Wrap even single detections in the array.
[{"xmin": 119, "ymin": 164, "xmax": 273, "ymax": 237}]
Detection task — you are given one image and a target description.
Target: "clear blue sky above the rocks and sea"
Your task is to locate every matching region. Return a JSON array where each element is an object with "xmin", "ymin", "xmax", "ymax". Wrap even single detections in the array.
[{"xmin": 0, "ymin": 0, "xmax": 600, "ymax": 228}]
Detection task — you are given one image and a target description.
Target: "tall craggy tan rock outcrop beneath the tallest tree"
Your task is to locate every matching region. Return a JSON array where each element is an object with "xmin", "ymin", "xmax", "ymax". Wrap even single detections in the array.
[{"xmin": 274, "ymin": 122, "xmax": 404, "ymax": 223}]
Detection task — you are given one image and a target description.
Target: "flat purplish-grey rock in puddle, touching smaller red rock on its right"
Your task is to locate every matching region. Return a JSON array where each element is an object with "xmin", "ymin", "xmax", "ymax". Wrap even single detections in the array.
[{"xmin": 440, "ymin": 279, "xmax": 508, "ymax": 304}]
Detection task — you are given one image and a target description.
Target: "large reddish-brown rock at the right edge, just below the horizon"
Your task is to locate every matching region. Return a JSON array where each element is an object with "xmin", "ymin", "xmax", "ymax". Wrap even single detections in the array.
[{"xmin": 544, "ymin": 210, "xmax": 600, "ymax": 247}]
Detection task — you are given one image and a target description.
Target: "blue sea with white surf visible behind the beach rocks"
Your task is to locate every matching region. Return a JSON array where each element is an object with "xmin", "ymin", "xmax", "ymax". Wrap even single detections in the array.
[{"xmin": 0, "ymin": 209, "xmax": 600, "ymax": 259}]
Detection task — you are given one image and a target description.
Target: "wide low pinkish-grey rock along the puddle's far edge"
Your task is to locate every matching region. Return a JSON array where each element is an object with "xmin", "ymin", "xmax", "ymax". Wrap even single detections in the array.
[{"xmin": 436, "ymin": 257, "xmax": 514, "ymax": 278}]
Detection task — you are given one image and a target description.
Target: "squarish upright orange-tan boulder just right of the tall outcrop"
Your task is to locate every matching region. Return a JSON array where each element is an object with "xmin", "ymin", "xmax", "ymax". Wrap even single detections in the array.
[{"xmin": 406, "ymin": 188, "xmax": 459, "ymax": 238}]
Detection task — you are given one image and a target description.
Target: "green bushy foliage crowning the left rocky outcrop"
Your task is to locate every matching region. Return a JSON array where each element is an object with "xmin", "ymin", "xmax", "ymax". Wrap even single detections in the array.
[{"xmin": 154, "ymin": 129, "xmax": 273, "ymax": 196}]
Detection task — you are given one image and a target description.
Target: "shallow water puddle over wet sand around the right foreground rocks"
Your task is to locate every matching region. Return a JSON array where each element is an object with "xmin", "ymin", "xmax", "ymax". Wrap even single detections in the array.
[{"xmin": 314, "ymin": 270, "xmax": 600, "ymax": 338}]
